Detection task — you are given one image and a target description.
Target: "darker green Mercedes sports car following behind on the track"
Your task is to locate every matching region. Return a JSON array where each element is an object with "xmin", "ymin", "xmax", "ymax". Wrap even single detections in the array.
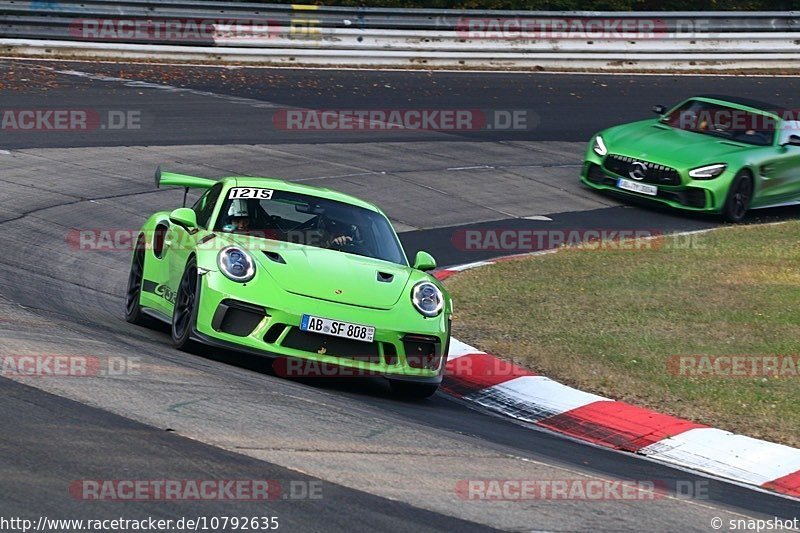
[{"xmin": 581, "ymin": 96, "xmax": 800, "ymax": 222}]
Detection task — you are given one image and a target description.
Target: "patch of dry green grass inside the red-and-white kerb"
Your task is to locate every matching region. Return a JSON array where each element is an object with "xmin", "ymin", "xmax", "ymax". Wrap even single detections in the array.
[{"xmin": 446, "ymin": 222, "xmax": 800, "ymax": 446}]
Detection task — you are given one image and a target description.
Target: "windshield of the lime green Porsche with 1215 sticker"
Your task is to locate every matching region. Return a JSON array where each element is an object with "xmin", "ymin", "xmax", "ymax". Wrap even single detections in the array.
[{"xmin": 214, "ymin": 187, "xmax": 408, "ymax": 265}]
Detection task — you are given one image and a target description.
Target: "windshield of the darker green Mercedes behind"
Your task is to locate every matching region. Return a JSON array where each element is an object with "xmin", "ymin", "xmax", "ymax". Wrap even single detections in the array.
[{"xmin": 661, "ymin": 100, "xmax": 778, "ymax": 146}]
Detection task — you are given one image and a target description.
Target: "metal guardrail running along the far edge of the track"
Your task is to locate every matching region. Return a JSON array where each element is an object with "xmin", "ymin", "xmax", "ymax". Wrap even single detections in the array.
[{"xmin": 0, "ymin": 0, "xmax": 800, "ymax": 69}]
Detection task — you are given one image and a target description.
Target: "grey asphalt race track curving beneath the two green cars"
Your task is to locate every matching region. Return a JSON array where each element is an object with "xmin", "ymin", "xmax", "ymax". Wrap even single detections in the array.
[{"xmin": 0, "ymin": 60, "xmax": 800, "ymax": 531}]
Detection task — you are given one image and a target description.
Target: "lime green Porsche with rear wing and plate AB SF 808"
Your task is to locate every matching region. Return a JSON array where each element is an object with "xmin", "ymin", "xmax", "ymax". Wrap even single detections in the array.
[{"xmin": 126, "ymin": 169, "xmax": 452, "ymax": 397}]
